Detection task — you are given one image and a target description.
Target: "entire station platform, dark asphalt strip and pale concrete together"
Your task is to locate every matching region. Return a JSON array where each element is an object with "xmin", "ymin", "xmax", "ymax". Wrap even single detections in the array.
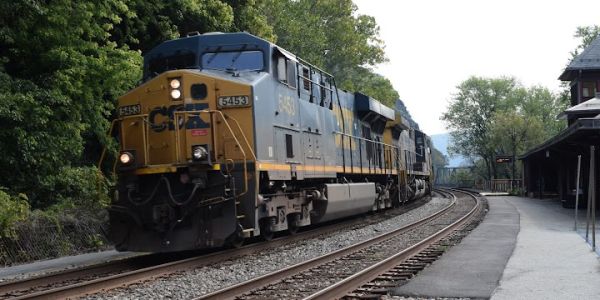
[{"xmin": 392, "ymin": 196, "xmax": 600, "ymax": 299}]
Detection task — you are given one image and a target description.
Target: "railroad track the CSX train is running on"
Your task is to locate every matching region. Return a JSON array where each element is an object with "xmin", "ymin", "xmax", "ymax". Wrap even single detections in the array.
[{"xmin": 0, "ymin": 193, "xmax": 440, "ymax": 299}]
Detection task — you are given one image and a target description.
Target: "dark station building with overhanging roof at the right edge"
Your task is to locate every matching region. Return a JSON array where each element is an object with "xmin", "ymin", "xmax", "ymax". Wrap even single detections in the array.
[{"xmin": 520, "ymin": 36, "xmax": 600, "ymax": 207}]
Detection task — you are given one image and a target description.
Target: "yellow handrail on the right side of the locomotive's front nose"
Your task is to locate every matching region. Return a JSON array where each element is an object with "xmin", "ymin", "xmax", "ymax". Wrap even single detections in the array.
[{"xmin": 174, "ymin": 109, "xmax": 250, "ymax": 197}]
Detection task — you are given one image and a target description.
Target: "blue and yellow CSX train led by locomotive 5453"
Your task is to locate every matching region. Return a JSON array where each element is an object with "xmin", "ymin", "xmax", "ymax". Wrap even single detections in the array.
[{"xmin": 109, "ymin": 33, "xmax": 432, "ymax": 252}]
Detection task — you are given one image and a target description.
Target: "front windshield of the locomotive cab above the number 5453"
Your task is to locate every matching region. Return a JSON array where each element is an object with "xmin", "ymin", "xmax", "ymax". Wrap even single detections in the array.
[{"xmin": 202, "ymin": 51, "xmax": 264, "ymax": 71}]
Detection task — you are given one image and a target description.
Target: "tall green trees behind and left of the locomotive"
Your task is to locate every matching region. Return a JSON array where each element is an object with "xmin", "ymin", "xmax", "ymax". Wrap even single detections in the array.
[{"xmin": 0, "ymin": 0, "xmax": 399, "ymax": 259}]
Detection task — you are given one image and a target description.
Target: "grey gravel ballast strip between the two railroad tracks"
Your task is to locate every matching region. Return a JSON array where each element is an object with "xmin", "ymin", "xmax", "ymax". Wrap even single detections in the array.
[{"xmin": 83, "ymin": 197, "xmax": 451, "ymax": 299}]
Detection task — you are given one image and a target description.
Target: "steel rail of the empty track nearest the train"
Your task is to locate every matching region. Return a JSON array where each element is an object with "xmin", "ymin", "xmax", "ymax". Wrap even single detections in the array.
[{"xmin": 194, "ymin": 189, "xmax": 456, "ymax": 300}]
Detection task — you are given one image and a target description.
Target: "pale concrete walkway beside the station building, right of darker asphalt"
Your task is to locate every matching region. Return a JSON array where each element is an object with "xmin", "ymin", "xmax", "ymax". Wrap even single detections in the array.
[{"xmin": 490, "ymin": 197, "xmax": 600, "ymax": 299}]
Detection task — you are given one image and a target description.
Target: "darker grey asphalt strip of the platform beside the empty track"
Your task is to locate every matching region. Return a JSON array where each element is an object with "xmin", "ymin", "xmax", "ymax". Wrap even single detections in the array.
[{"xmin": 393, "ymin": 198, "xmax": 519, "ymax": 298}]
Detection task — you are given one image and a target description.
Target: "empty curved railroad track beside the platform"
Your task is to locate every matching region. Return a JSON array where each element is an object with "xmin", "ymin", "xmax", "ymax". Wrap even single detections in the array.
[{"xmin": 196, "ymin": 191, "xmax": 482, "ymax": 300}]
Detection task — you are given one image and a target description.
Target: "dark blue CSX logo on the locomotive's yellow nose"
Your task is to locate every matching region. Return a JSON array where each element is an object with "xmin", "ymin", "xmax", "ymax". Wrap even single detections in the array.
[{"xmin": 148, "ymin": 103, "xmax": 210, "ymax": 132}]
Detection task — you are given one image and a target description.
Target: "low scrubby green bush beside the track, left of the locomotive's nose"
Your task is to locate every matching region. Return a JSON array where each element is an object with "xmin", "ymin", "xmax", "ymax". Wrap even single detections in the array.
[{"xmin": 0, "ymin": 167, "xmax": 110, "ymax": 265}]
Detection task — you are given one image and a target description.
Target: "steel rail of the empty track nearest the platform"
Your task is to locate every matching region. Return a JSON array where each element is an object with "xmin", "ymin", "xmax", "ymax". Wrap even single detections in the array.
[{"xmin": 304, "ymin": 191, "xmax": 482, "ymax": 300}]
